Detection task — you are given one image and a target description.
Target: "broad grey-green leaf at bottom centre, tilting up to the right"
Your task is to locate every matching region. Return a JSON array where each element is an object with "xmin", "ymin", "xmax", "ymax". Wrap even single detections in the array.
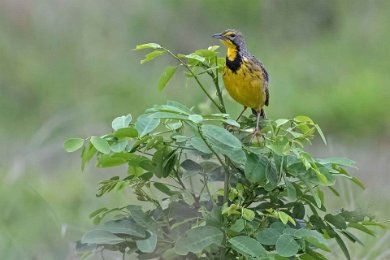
[{"xmin": 174, "ymin": 226, "xmax": 223, "ymax": 255}]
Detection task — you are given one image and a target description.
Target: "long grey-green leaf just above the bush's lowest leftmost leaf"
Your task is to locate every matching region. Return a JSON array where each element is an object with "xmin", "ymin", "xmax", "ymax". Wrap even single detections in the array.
[{"xmin": 97, "ymin": 219, "xmax": 146, "ymax": 238}]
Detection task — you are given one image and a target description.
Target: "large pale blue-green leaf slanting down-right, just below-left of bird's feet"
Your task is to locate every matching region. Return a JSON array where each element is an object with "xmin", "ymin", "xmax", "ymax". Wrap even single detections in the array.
[{"xmin": 201, "ymin": 125, "xmax": 246, "ymax": 164}]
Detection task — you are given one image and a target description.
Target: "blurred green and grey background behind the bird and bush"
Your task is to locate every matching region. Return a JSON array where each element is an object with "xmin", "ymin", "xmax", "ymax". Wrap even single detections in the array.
[{"xmin": 0, "ymin": 0, "xmax": 390, "ymax": 259}]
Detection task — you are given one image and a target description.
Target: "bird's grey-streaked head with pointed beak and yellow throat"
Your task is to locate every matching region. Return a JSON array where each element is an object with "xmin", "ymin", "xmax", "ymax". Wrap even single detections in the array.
[{"xmin": 213, "ymin": 29, "xmax": 246, "ymax": 60}]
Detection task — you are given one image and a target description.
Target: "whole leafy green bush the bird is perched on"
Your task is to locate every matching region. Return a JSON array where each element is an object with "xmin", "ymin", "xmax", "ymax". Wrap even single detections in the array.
[{"xmin": 64, "ymin": 43, "xmax": 384, "ymax": 259}]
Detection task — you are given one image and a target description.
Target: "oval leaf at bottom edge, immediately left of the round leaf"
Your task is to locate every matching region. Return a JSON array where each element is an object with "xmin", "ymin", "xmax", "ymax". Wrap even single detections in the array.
[{"xmin": 229, "ymin": 236, "xmax": 267, "ymax": 257}]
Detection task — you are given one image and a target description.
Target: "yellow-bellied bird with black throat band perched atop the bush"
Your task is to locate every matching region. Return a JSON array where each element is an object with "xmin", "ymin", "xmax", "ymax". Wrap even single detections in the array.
[{"xmin": 213, "ymin": 29, "xmax": 269, "ymax": 134}]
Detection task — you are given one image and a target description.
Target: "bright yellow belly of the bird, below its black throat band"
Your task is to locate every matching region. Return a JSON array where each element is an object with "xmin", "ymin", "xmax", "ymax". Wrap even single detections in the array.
[{"xmin": 223, "ymin": 67, "xmax": 265, "ymax": 110}]
